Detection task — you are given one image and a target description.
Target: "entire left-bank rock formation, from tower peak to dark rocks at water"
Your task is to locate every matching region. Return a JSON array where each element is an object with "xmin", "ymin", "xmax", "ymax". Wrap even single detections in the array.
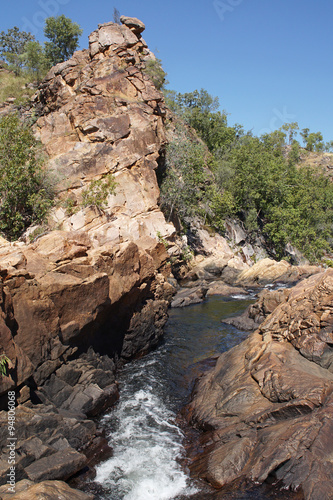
[{"xmin": 0, "ymin": 18, "xmax": 175, "ymax": 490}]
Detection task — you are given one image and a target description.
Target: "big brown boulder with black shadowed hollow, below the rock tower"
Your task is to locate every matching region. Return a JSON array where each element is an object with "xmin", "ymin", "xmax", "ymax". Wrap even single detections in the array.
[{"xmin": 0, "ymin": 236, "xmax": 173, "ymax": 396}]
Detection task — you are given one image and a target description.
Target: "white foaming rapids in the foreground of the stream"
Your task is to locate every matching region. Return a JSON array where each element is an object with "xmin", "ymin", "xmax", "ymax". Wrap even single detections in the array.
[{"xmin": 95, "ymin": 360, "xmax": 196, "ymax": 500}]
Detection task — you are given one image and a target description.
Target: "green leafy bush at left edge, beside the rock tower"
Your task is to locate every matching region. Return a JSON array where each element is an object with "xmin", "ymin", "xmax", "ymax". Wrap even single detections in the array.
[{"xmin": 0, "ymin": 114, "xmax": 52, "ymax": 239}]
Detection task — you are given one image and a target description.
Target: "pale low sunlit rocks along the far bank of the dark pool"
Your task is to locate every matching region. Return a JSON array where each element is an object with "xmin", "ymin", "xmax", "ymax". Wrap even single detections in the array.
[{"xmin": 171, "ymin": 253, "xmax": 322, "ymax": 308}]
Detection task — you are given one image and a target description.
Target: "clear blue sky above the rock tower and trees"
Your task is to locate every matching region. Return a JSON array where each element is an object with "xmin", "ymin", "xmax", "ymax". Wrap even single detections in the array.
[{"xmin": 0, "ymin": 0, "xmax": 333, "ymax": 141}]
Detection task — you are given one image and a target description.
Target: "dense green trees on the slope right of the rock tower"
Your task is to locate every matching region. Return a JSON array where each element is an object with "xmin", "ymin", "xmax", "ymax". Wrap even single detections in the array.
[{"xmin": 161, "ymin": 90, "xmax": 333, "ymax": 261}]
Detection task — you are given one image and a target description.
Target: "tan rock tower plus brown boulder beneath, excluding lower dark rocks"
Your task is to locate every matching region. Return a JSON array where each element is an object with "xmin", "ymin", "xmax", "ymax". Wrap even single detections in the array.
[{"xmin": 0, "ymin": 18, "xmax": 175, "ymax": 395}]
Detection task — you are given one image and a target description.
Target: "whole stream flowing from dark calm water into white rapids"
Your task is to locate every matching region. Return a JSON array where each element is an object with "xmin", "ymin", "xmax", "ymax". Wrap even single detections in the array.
[{"xmin": 89, "ymin": 297, "xmax": 298, "ymax": 500}]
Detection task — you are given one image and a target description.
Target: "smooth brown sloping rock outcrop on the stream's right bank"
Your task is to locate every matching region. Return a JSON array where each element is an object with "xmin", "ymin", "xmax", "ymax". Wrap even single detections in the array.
[{"xmin": 187, "ymin": 270, "xmax": 333, "ymax": 500}]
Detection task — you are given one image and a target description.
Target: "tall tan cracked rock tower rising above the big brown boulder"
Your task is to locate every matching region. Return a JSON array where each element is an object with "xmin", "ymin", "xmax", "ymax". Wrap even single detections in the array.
[{"xmin": 36, "ymin": 23, "xmax": 174, "ymax": 244}]
